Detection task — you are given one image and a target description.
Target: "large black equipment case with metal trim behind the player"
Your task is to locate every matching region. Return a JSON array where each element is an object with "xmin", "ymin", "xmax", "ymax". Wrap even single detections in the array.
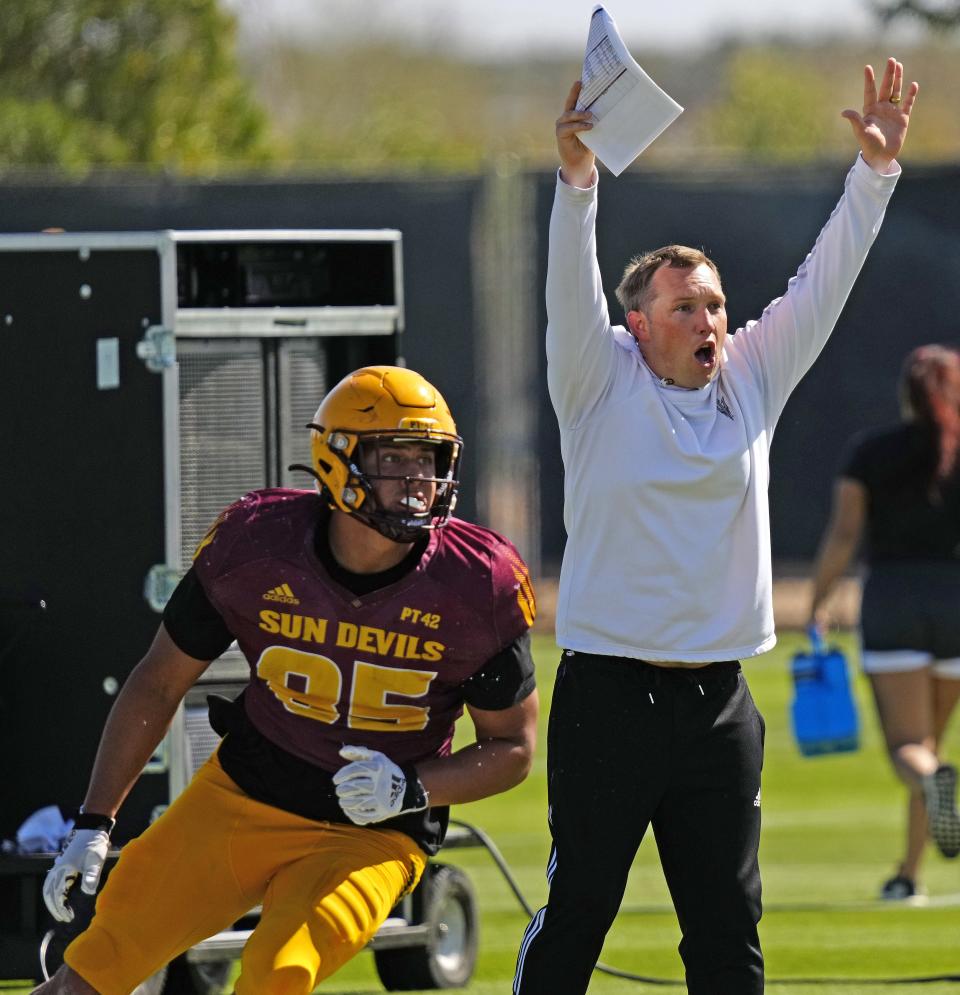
[{"xmin": 0, "ymin": 229, "xmax": 403, "ymax": 978}]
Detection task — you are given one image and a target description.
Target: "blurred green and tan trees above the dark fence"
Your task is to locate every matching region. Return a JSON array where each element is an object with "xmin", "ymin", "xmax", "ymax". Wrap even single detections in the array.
[{"xmin": 0, "ymin": 0, "xmax": 960, "ymax": 175}]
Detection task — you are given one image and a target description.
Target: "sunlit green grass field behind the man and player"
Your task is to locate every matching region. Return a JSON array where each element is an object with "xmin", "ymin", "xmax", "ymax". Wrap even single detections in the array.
[{"xmin": 7, "ymin": 633, "xmax": 960, "ymax": 995}]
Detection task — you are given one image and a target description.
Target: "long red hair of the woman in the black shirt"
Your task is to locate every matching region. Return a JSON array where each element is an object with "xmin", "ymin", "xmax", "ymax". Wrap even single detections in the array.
[{"xmin": 900, "ymin": 345, "xmax": 960, "ymax": 499}]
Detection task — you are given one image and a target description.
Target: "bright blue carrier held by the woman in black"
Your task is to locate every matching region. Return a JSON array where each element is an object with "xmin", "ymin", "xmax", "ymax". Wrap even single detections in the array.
[{"xmin": 790, "ymin": 633, "xmax": 860, "ymax": 757}]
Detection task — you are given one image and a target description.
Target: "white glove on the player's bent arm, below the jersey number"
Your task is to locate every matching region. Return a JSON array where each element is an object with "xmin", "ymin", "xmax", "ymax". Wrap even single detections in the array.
[{"xmin": 333, "ymin": 746, "xmax": 429, "ymax": 826}]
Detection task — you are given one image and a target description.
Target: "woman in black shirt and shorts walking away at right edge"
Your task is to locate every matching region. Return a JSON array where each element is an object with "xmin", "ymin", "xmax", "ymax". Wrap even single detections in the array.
[{"xmin": 810, "ymin": 345, "xmax": 960, "ymax": 901}]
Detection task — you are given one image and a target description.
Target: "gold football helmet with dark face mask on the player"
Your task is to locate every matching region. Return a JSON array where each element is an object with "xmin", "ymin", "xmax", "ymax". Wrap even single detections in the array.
[{"xmin": 291, "ymin": 366, "xmax": 463, "ymax": 542}]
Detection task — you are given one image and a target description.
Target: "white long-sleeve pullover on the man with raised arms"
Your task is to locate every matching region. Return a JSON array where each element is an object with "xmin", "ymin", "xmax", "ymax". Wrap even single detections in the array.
[{"xmin": 546, "ymin": 156, "xmax": 900, "ymax": 663}]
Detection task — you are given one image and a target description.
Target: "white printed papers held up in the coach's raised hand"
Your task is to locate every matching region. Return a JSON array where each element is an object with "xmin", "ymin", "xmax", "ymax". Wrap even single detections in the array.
[{"xmin": 577, "ymin": 4, "xmax": 683, "ymax": 176}]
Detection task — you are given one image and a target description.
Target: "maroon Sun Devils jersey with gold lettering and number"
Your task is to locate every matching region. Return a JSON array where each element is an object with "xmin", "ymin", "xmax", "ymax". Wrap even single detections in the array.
[{"xmin": 194, "ymin": 489, "xmax": 535, "ymax": 772}]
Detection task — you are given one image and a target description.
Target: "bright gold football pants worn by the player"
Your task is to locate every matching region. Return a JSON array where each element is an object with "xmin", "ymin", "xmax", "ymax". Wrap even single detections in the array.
[{"xmin": 65, "ymin": 755, "xmax": 427, "ymax": 995}]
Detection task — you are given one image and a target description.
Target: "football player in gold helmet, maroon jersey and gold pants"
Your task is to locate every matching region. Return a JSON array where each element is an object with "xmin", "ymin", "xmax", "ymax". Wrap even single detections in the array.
[{"xmin": 37, "ymin": 366, "xmax": 537, "ymax": 995}]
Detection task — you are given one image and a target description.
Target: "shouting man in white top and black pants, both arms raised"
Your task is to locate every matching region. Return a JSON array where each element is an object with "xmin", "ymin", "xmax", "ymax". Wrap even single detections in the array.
[{"xmin": 514, "ymin": 59, "xmax": 919, "ymax": 995}]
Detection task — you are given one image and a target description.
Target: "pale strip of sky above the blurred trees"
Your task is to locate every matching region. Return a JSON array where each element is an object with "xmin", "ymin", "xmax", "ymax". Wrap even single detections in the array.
[{"xmin": 223, "ymin": 0, "xmax": 928, "ymax": 57}]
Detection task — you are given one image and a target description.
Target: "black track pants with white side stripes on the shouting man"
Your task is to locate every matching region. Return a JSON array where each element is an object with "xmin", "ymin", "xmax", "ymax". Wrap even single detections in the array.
[{"xmin": 513, "ymin": 651, "xmax": 764, "ymax": 995}]
